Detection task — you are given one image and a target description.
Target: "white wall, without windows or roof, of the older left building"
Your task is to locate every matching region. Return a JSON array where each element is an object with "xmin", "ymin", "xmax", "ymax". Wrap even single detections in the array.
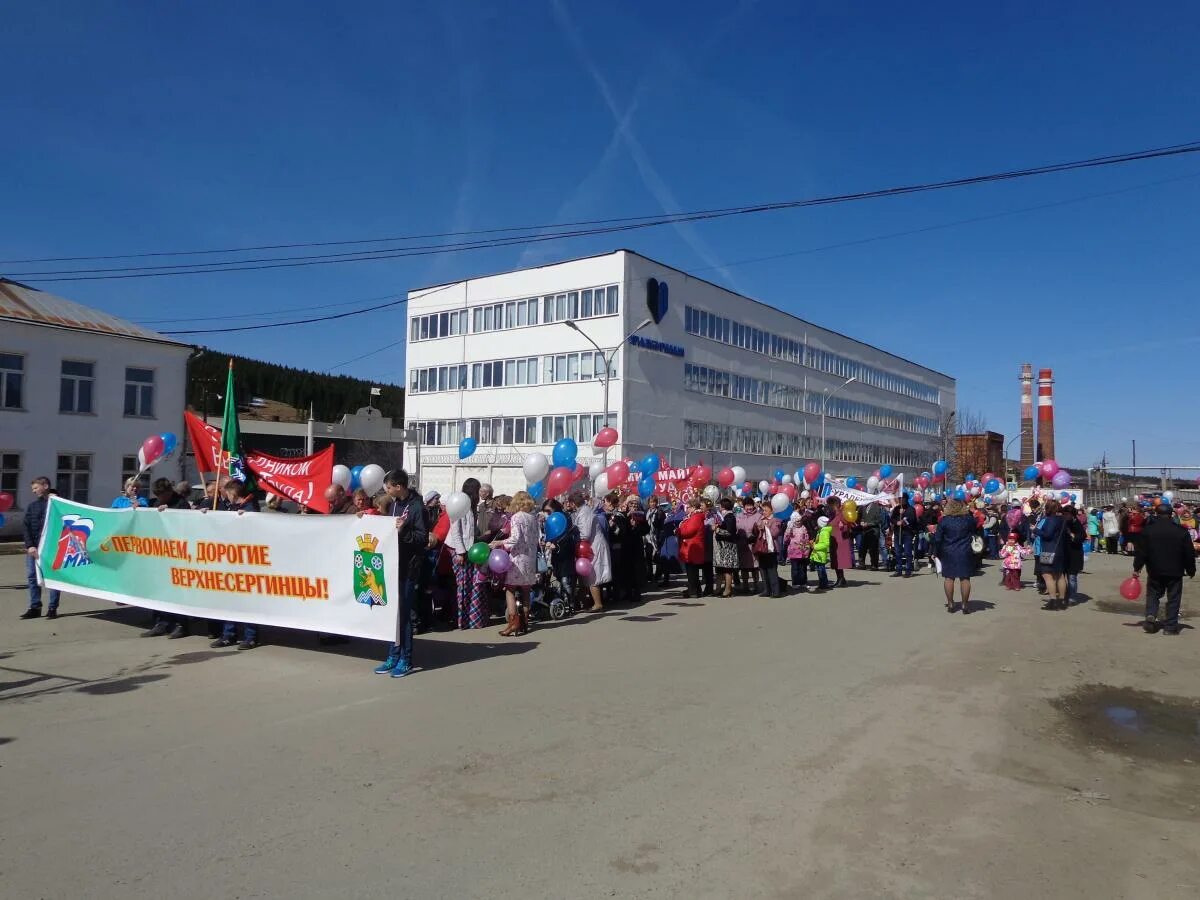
[{"xmin": 0, "ymin": 320, "xmax": 191, "ymax": 534}]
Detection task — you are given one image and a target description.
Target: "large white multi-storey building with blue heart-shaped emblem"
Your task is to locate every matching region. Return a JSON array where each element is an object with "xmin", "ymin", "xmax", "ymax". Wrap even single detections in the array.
[{"xmin": 404, "ymin": 250, "xmax": 955, "ymax": 492}]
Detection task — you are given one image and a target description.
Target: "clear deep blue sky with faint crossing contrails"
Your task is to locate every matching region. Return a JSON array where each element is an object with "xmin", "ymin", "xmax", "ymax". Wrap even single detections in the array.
[{"xmin": 0, "ymin": 0, "xmax": 1200, "ymax": 475}]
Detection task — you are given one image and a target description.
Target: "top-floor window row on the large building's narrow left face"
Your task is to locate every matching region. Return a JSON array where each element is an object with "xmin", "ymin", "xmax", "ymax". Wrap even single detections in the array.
[{"xmin": 408, "ymin": 284, "xmax": 620, "ymax": 341}]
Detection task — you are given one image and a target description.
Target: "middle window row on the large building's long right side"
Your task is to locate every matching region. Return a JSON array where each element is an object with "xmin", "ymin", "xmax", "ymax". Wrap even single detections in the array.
[{"xmin": 684, "ymin": 362, "xmax": 937, "ymax": 434}]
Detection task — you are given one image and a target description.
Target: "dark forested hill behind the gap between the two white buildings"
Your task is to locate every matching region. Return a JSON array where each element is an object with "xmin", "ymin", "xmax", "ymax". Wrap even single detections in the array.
[{"xmin": 187, "ymin": 350, "xmax": 404, "ymax": 426}]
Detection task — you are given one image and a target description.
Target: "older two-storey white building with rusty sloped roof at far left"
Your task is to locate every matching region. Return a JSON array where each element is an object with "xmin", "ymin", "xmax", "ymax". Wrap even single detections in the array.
[{"xmin": 0, "ymin": 278, "xmax": 192, "ymax": 534}]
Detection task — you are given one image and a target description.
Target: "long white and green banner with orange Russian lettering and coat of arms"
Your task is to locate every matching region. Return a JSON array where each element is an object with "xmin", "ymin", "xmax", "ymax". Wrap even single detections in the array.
[{"xmin": 38, "ymin": 497, "xmax": 401, "ymax": 641}]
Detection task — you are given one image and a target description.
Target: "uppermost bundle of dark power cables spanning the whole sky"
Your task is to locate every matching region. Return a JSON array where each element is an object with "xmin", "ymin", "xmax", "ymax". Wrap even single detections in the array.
[{"xmin": 12, "ymin": 142, "xmax": 1200, "ymax": 282}]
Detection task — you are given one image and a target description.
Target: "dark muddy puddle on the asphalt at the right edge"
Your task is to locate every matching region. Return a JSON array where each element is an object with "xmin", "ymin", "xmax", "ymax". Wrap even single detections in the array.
[{"xmin": 1051, "ymin": 684, "xmax": 1200, "ymax": 764}]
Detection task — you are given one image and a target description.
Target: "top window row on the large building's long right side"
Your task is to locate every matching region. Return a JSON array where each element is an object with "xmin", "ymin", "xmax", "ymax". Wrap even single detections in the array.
[{"xmin": 684, "ymin": 306, "xmax": 940, "ymax": 403}]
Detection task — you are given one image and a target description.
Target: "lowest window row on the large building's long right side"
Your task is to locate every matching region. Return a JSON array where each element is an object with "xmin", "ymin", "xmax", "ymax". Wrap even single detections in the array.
[{"xmin": 684, "ymin": 420, "xmax": 929, "ymax": 468}]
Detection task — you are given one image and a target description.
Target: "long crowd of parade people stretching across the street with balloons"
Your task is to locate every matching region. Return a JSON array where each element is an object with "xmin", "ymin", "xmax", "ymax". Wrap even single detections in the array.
[{"xmin": 22, "ymin": 469, "xmax": 1200, "ymax": 677}]
